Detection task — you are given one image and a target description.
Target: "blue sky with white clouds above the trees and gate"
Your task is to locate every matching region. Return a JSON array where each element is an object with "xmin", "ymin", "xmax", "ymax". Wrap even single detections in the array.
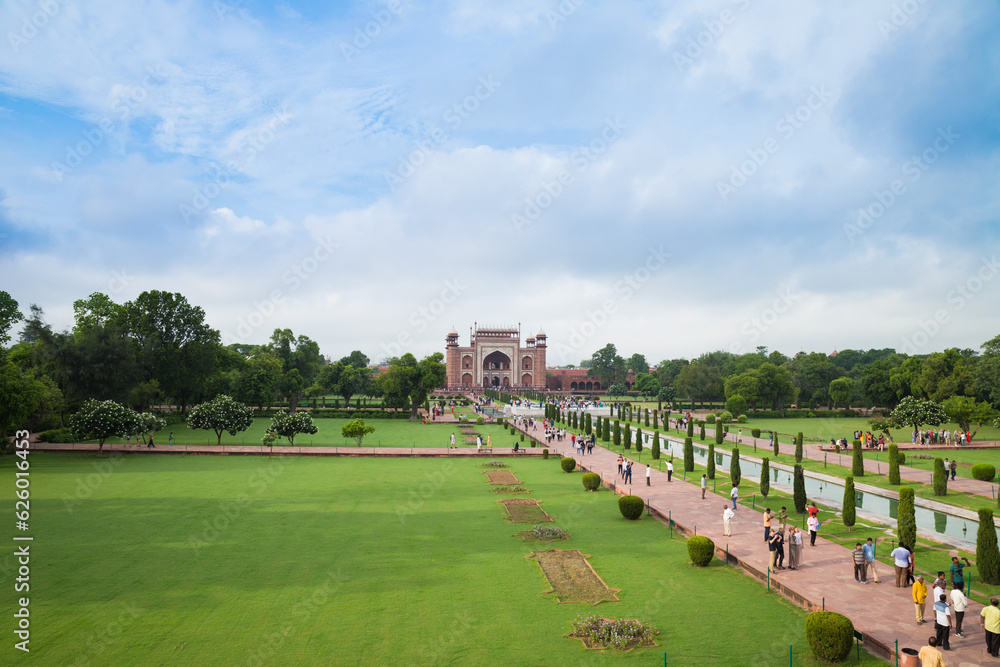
[{"xmin": 0, "ymin": 0, "xmax": 1000, "ymax": 364}]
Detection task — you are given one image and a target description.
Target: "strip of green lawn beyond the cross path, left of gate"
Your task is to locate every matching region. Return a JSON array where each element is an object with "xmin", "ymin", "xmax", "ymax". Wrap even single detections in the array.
[{"xmin": 100, "ymin": 418, "xmax": 528, "ymax": 447}]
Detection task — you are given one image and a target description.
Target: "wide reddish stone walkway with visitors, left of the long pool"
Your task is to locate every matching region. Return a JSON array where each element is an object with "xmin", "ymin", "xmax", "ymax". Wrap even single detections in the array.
[{"xmin": 512, "ymin": 429, "xmax": 1000, "ymax": 666}]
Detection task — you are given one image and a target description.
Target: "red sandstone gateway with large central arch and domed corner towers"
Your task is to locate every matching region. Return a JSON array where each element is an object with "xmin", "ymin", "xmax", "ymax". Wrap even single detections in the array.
[{"xmin": 445, "ymin": 324, "xmax": 547, "ymax": 391}]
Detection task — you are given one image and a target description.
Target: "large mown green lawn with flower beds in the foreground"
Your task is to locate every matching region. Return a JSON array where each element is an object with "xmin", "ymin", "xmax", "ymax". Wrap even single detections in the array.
[{"xmin": 0, "ymin": 453, "xmax": 883, "ymax": 665}]
